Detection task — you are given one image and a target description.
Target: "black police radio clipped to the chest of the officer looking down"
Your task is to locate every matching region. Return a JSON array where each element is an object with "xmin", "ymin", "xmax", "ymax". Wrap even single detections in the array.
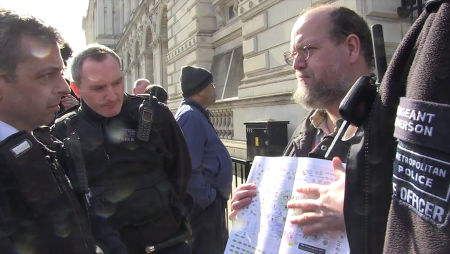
[{"xmin": 136, "ymin": 96, "xmax": 153, "ymax": 142}]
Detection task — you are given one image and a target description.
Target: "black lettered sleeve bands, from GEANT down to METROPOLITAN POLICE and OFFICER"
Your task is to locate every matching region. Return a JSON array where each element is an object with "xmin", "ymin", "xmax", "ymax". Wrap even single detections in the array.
[{"xmin": 392, "ymin": 97, "xmax": 450, "ymax": 227}]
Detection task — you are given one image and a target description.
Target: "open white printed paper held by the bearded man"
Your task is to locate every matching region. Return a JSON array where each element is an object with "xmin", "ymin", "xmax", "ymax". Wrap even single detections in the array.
[{"xmin": 225, "ymin": 156, "xmax": 350, "ymax": 254}]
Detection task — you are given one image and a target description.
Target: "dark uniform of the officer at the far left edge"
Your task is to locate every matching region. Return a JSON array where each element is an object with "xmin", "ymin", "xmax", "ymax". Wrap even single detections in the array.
[{"xmin": 0, "ymin": 131, "xmax": 95, "ymax": 254}]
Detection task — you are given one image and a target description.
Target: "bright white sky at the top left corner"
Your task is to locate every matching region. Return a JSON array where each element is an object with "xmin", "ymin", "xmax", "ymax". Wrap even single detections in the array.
[{"xmin": 0, "ymin": 0, "xmax": 89, "ymax": 52}]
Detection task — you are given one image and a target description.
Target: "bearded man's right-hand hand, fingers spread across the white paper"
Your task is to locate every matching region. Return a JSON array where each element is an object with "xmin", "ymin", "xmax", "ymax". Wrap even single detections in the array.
[{"xmin": 287, "ymin": 157, "xmax": 345, "ymax": 235}]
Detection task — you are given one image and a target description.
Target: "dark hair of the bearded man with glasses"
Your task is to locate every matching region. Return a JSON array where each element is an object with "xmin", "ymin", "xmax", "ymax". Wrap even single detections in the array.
[{"xmin": 330, "ymin": 7, "xmax": 373, "ymax": 66}]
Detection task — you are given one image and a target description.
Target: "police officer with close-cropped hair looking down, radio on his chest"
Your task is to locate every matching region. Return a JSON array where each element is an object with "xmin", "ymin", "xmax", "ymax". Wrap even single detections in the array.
[{"xmin": 53, "ymin": 44, "xmax": 191, "ymax": 253}]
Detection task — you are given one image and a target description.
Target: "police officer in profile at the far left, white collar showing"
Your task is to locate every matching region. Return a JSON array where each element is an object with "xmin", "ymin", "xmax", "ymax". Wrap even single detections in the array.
[{"xmin": 0, "ymin": 9, "xmax": 105, "ymax": 254}]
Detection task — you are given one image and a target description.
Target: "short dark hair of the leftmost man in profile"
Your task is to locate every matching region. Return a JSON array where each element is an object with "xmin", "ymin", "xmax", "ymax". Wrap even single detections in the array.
[{"xmin": 0, "ymin": 8, "xmax": 64, "ymax": 81}]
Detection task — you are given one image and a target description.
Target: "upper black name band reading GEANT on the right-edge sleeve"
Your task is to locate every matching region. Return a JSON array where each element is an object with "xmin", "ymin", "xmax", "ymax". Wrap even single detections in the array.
[{"xmin": 394, "ymin": 97, "xmax": 450, "ymax": 153}]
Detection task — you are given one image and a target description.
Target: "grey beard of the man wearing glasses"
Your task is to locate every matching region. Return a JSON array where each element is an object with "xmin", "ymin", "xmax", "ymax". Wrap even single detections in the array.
[{"xmin": 293, "ymin": 78, "xmax": 352, "ymax": 109}]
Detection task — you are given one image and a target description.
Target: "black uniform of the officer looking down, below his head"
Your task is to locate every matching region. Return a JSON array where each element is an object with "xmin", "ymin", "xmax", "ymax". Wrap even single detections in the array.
[{"xmin": 53, "ymin": 94, "xmax": 192, "ymax": 253}]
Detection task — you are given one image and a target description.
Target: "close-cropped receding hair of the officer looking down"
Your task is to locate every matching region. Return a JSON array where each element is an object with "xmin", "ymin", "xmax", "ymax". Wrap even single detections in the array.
[{"xmin": 70, "ymin": 44, "xmax": 122, "ymax": 87}]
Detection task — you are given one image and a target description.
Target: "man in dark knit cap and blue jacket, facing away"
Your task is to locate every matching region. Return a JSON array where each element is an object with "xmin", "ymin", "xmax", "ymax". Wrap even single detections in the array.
[{"xmin": 175, "ymin": 66, "xmax": 232, "ymax": 254}]
